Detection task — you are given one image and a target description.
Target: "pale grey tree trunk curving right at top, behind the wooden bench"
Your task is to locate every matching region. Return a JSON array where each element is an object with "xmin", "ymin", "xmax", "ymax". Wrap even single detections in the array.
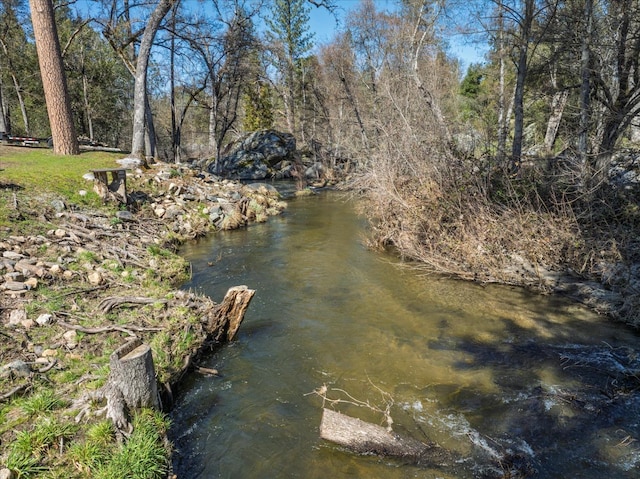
[{"xmin": 131, "ymin": 0, "xmax": 176, "ymax": 159}]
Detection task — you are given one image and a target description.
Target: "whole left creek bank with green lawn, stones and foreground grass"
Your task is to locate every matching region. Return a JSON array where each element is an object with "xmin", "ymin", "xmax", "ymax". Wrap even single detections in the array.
[{"xmin": 0, "ymin": 148, "xmax": 282, "ymax": 479}]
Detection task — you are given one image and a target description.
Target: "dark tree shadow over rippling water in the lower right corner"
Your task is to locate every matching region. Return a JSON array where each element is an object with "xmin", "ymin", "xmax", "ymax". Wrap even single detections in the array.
[{"xmin": 448, "ymin": 318, "xmax": 640, "ymax": 478}]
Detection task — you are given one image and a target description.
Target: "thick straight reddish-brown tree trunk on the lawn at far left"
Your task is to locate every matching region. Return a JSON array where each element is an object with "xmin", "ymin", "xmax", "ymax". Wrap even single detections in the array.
[{"xmin": 30, "ymin": 0, "xmax": 80, "ymax": 155}]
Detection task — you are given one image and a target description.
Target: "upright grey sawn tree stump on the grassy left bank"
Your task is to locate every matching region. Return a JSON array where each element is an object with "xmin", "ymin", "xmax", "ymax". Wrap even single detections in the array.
[{"xmin": 105, "ymin": 339, "xmax": 160, "ymax": 429}]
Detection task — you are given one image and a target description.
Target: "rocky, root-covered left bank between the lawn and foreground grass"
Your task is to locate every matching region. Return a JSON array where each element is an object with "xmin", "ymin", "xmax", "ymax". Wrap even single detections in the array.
[{"xmin": 0, "ymin": 164, "xmax": 286, "ymax": 477}]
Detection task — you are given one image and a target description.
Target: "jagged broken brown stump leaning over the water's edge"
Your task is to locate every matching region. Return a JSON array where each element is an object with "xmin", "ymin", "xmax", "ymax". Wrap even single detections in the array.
[{"xmin": 207, "ymin": 285, "xmax": 256, "ymax": 341}]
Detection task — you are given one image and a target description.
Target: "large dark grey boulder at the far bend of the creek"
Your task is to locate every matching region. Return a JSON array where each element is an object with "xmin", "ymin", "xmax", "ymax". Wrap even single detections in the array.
[{"xmin": 209, "ymin": 130, "xmax": 296, "ymax": 180}]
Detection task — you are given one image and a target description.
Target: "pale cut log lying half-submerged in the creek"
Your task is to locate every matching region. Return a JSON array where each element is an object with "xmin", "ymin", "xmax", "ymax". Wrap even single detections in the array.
[{"xmin": 320, "ymin": 408, "xmax": 451, "ymax": 466}]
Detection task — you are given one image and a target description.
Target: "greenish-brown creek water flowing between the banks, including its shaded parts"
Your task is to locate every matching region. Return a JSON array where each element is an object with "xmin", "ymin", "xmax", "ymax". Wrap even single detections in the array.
[{"xmin": 170, "ymin": 189, "xmax": 640, "ymax": 479}]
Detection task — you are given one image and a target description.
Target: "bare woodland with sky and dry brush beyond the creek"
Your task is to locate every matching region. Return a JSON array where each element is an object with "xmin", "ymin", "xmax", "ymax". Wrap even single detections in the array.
[{"xmin": 0, "ymin": 0, "xmax": 640, "ymax": 322}]
